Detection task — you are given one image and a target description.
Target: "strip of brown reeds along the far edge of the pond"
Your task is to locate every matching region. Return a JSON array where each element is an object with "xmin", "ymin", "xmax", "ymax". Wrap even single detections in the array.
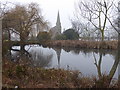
[{"xmin": 45, "ymin": 40, "xmax": 117, "ymax": 49}]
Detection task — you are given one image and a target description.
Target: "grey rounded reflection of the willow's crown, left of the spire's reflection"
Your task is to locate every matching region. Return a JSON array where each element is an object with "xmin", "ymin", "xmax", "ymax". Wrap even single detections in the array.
[{"xmin": 30, "ymin": 50, "xmax": 53, "ymax": 67}]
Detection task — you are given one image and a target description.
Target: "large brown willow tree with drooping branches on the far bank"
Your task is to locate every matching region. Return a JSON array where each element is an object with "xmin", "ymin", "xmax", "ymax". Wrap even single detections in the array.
[{"xmin": 3, "ymin": 3, "xmax": 47, "ymax": 49}]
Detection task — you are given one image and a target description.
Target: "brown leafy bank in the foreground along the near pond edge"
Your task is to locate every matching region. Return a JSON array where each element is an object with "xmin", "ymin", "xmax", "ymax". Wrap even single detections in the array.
[{"xmin": 2, "ymin": 59, "xmax": 120, "ymax": 88}]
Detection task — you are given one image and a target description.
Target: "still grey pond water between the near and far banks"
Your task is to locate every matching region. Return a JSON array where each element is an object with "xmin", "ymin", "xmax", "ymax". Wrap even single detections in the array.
[{"xmin": 11, "ymin": 45, "xmax": 120, "ymax": 79}]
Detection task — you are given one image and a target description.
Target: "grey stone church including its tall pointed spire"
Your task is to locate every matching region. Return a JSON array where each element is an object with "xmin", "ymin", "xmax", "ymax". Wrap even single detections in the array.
[{"xmin": 50, "ymin": 11, "xmax": 61, "ymax": 40}]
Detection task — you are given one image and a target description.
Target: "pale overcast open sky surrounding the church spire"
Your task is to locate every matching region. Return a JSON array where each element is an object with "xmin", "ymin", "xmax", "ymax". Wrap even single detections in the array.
[{"xmin": 0, "ymin": 0, "xmax": 78, "ymax": 30}]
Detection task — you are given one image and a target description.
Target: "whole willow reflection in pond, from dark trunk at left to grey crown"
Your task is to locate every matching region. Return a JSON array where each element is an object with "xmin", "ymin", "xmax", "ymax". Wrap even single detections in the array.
[{"xmin": 7, "ymin": 46, "xmax": 53, "ymax": 67}]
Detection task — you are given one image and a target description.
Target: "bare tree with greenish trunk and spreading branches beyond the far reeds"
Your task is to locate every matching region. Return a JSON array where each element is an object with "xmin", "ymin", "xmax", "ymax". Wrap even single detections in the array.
[{"xmin": 74, "ymin": 0, "xmax": 114, "ymax": 41}]
